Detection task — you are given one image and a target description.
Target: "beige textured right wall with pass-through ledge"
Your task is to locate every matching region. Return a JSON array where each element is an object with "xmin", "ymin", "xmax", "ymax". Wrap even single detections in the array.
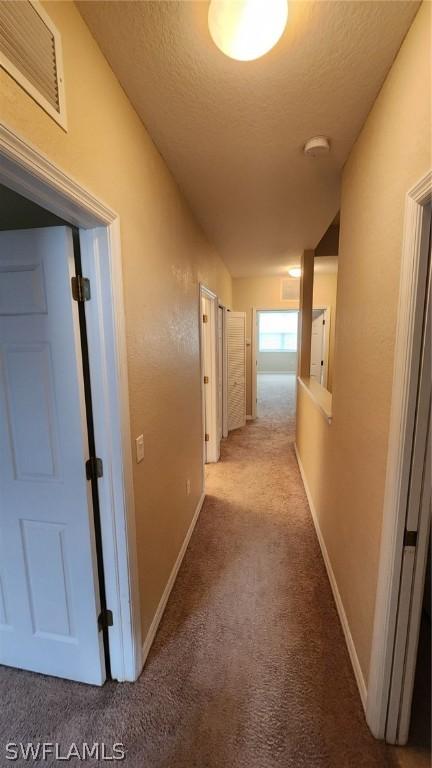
[{"xmin": 297, "ymin": 3, "xmax": 431, "ymax": 680}]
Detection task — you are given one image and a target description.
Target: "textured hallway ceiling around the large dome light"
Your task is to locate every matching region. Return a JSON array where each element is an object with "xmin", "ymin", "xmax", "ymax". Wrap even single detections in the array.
[{"xmin": 78, "ymin": 0, "xmax": 418, "ymax": 276}]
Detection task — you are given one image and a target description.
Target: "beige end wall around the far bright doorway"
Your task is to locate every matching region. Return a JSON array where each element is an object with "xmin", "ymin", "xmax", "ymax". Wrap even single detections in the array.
[{"xmin": 232, "ymin": 273, "xmax": 336, "ymax": 414}]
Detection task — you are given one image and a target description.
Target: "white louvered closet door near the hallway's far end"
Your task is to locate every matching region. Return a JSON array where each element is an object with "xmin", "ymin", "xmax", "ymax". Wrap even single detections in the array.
[{"xmin": 227, "ymin": 312, "xmax": 246, "ymax": 431}]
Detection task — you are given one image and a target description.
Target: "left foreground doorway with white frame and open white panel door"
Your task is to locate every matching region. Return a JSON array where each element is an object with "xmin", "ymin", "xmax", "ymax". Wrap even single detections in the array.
[{"xmin": 0, "ymin": 127, "xmax": 142, "ymax": 685}]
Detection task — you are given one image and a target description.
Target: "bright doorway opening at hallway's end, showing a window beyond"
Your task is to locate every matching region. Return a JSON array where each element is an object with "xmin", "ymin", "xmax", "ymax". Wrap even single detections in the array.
[{"xmin": 252, "ymin": 309, "xmax": 298, "ymax": 418}]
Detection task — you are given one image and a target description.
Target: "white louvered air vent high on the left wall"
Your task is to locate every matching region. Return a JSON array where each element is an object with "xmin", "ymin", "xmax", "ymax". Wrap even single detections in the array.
[{"xmin": 0, "ymin": 0, "xmax": 66, "ymax": 130}]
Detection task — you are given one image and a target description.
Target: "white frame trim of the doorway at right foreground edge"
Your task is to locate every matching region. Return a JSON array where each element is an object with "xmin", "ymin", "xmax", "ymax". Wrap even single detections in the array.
[{"xmin": 366, "ymin": 171, "xmax": 432, "ymax": 739}]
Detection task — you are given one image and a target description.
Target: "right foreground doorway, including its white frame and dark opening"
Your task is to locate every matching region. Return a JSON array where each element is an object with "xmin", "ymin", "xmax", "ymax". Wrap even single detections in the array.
[{"xmin": 366, "ymin": 172, "xmax": 432, "ymax": 752}]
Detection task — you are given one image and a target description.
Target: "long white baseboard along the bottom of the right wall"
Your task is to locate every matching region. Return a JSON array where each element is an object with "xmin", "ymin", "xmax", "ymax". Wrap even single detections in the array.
[{"xmin": 294, "ymin": 443, "xmax": 367, "ymax": 711}]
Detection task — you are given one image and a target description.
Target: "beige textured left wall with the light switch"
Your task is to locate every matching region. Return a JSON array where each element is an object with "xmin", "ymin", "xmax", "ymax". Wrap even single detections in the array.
[{"xmin": 0, "ymin": 2, "xmax": 231, "ymax": 634}]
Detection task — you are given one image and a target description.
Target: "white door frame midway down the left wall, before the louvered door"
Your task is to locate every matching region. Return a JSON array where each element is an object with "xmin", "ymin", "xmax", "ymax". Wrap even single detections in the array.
[{"xmin": 199, "ymin": 283, "xmax": 220, "ymax": 463}]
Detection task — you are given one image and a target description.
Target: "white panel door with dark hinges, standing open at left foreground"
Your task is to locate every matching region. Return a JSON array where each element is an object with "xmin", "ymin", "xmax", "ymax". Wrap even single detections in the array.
[{"xmin": 0, "ymin": 227, "xmax": 105, "ymax": 685}]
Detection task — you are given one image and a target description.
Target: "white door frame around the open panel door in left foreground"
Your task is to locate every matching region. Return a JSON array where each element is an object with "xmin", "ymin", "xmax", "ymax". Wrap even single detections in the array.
[{"xmin": 0, "ymin": 125, "xmax": 142, "ymax": 681}]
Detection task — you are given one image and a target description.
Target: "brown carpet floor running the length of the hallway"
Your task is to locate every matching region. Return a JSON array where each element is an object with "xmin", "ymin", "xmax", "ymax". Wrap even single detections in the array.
[{"xmin": 0, "ymin": 376, "xmax": 404, "ymax": 768}]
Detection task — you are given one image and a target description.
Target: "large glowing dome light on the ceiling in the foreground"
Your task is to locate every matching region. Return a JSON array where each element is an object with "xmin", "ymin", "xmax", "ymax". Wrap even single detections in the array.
[{"xmin": 208, "ymin": 0, "xmax": 288, "ymax": 61}]
